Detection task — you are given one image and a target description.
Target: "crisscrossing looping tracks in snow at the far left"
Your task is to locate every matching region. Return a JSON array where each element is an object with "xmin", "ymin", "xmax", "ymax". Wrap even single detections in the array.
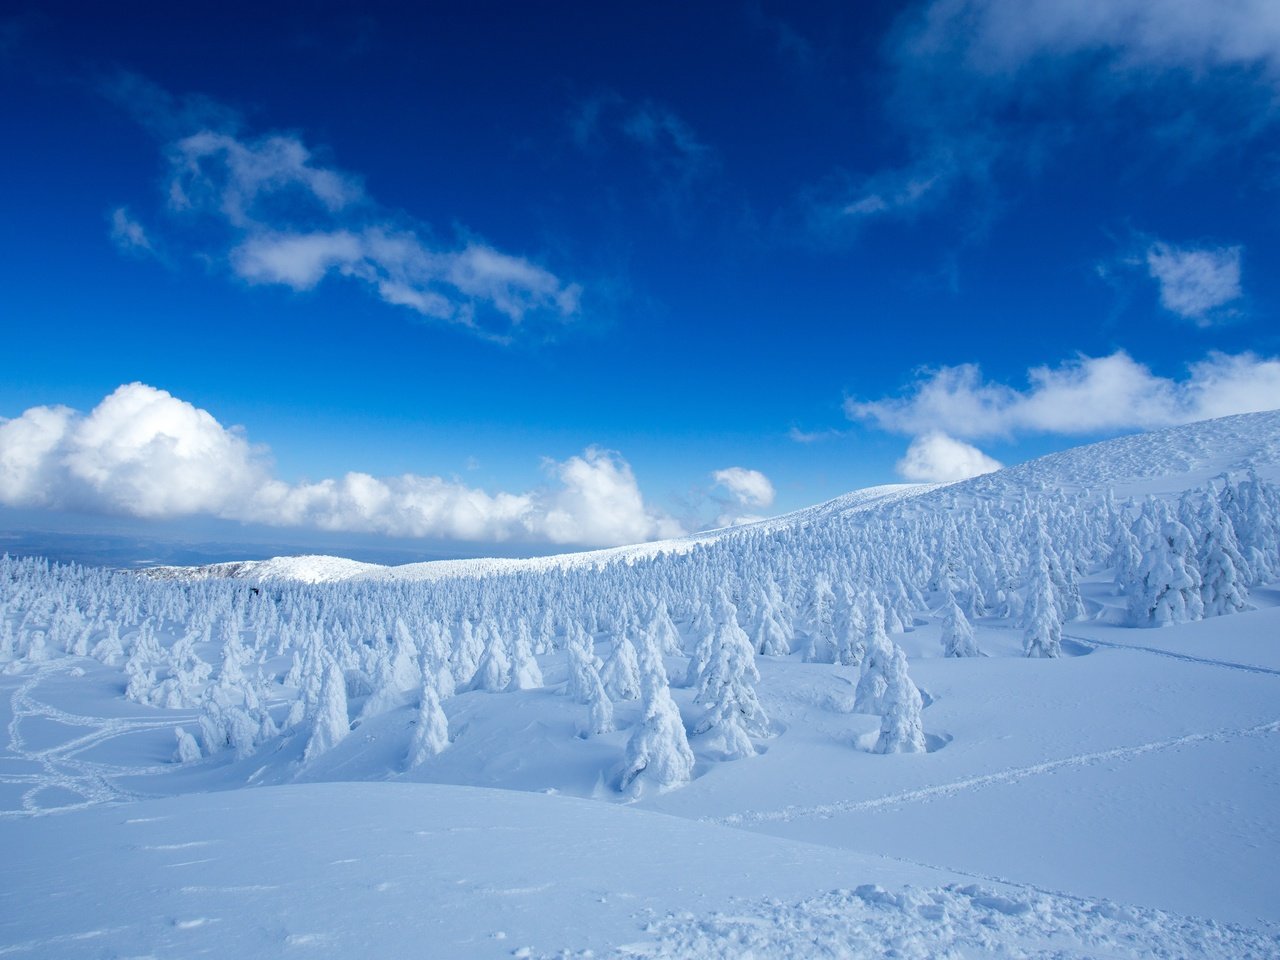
[{"xmin": 0, "ymin": 662, "xmax": 195, "ymax": 819}]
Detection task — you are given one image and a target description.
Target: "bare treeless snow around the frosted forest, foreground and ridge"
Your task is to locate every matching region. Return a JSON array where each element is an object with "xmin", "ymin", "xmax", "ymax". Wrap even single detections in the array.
[{"xmin": 0, "ymin": 413, "xmax": 1280, "ymax": 957}]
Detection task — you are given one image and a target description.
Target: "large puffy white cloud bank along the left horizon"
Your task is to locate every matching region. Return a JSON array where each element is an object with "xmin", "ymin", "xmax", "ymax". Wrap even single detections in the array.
[{"xmin": 0, "ymin": 383, "xmax": 684, "ymax": 547}]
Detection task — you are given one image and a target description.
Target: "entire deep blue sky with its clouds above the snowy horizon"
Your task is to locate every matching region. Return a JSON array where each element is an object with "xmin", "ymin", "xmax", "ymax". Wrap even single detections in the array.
[{"xmin": 0, "ymin": 0, "xmax": 1280, "ymax": 556}]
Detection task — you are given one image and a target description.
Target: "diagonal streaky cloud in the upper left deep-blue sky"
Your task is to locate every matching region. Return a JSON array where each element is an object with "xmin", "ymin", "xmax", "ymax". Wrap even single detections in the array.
[{"xmin": 111, "ymin": 78, "xmax": 582, "ymax": 342}]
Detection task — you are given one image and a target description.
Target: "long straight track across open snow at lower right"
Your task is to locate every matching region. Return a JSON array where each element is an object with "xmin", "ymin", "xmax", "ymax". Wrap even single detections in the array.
[{"xmin": 703, "ymin": 719, "xmax": 1280, "ymax": 827}]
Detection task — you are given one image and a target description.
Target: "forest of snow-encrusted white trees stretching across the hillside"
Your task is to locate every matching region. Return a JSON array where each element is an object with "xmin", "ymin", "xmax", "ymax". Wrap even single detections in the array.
[{"xmin": 0, "ymin": 474, "xmax": 1280, "ymax": 792}]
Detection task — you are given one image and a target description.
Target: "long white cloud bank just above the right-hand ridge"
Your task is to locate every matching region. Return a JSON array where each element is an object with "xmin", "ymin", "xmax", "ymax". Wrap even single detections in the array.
[{"xmin": 845, "ymin": 351, "xmax": 1280, "ymax": 438}]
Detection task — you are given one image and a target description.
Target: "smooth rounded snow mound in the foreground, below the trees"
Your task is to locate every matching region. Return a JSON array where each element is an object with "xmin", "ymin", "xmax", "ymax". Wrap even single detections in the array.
[{"xmin": 0, "ymin": 783, "xmax": 1277, "ymax": 960}]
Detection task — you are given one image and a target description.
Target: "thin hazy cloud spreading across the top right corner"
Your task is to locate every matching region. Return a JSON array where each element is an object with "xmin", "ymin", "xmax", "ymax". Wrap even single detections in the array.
[{"xmin": 810, "ymin": 0, "xmax": 1280, "ymax": 230}]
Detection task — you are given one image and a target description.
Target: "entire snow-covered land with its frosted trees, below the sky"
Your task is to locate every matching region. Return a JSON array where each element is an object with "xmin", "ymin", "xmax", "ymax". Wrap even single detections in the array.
[{"xmin": 0, "ymin": 412, "xmax": 1280, "ymax": 957}]
